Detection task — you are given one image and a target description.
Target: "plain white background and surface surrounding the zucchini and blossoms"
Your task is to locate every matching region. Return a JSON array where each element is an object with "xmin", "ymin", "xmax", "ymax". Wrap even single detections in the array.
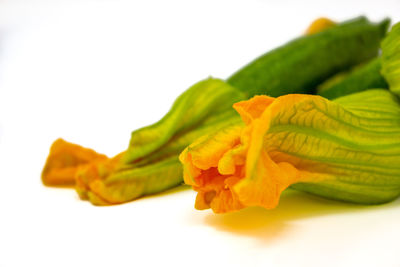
[{"xmin": 0, "ymin": 0, "xmax": 400, "ymax": 267}]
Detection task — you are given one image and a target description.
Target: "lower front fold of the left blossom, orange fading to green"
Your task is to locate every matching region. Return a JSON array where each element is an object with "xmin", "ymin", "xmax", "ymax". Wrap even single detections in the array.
[{"xmin": 76, "ymin": 156, "xmax": 182, "ymax": 205}]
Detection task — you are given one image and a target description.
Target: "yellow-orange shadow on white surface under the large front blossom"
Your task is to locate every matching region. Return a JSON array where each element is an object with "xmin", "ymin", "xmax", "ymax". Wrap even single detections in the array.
[{"xmin": 204, "ymin": 189, "xmax": 400, "ymax": 241}]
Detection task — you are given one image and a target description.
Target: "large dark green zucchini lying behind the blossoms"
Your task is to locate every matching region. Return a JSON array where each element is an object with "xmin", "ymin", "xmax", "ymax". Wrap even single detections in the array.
[{"xmin": 227, "ymin": 17, "xmax": 390, "ymax": 97}]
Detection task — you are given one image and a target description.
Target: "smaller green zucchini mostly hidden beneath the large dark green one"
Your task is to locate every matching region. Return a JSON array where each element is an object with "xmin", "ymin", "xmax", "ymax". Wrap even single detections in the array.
[{"xmin": 317, "ymin": 58, "xmax": 389, "ymax": 99}]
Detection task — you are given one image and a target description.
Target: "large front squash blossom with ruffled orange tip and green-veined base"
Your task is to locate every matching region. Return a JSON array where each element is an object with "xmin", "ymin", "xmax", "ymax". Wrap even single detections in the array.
[{"xmin": 180, "ymin": 89, "xmax": 400, "ymax": 213}]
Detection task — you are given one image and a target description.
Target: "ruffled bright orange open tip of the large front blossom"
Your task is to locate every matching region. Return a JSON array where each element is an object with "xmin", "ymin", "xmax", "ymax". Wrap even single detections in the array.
[{"xmin": 180, "ymin": 95, "xmax": 330, "ymax": 213}]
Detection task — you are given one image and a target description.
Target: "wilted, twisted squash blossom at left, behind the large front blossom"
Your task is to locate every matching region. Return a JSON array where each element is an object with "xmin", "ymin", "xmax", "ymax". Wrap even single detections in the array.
[{"xmin": 42, "ymin": 78, "xmax": 247, "ymax": 205}]
